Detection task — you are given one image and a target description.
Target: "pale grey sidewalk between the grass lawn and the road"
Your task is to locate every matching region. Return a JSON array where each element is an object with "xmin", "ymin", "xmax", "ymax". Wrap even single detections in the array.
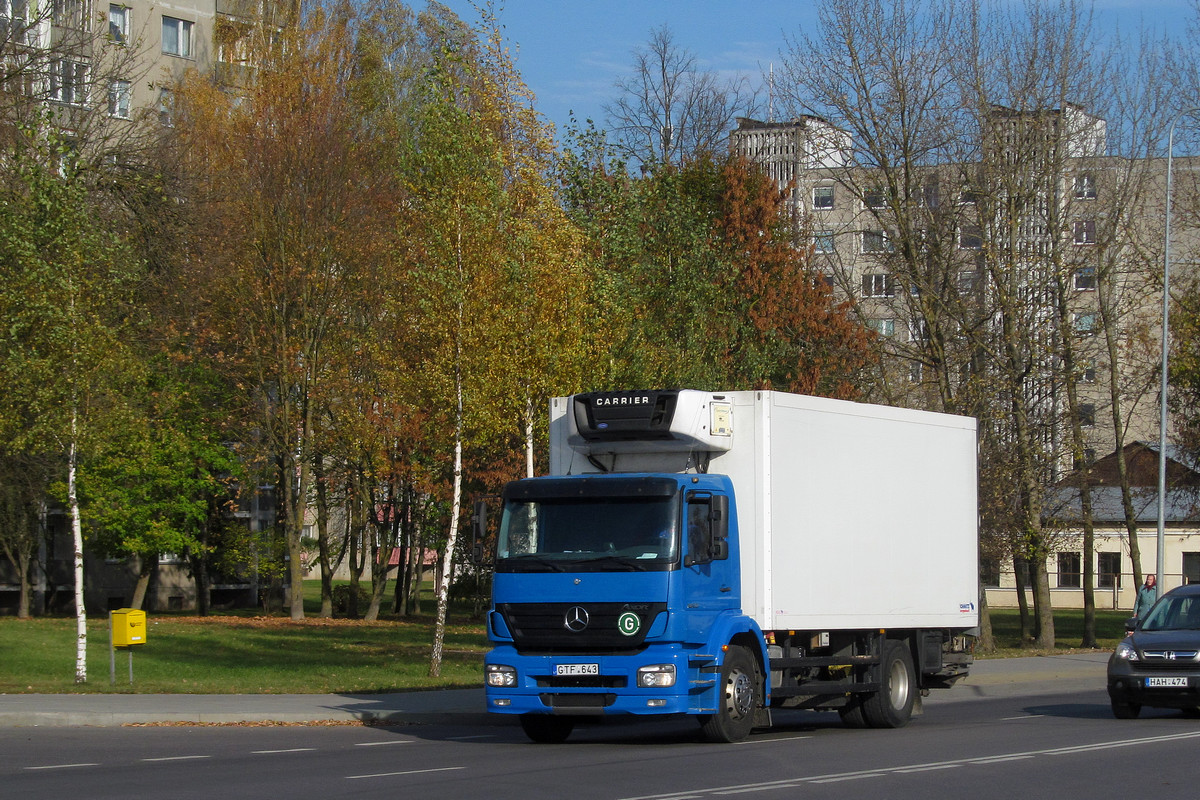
[{"xmin": 0, "ymin": 652, "xmax": 1109, "ymax": 728}]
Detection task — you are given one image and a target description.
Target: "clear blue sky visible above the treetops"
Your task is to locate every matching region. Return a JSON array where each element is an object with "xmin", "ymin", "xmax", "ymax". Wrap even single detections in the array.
[{"xmin": 427, "ymin": 0, "xmax": 1193, "ymax": 137}]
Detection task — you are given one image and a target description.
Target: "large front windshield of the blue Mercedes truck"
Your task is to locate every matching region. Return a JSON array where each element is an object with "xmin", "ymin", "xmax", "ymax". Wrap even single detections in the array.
[{"xmin": 496, "ymin": 497, "xmax": 679, "ymax": 572}]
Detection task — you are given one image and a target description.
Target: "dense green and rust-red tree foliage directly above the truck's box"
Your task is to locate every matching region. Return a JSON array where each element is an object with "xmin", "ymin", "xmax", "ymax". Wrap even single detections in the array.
[{"xmin": 560, "ymin": 130, "xmax": 870, "ymax": 397}]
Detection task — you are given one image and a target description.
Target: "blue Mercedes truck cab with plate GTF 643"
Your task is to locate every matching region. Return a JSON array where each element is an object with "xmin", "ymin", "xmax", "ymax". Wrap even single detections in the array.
[{"xmin": 485, "ymin": 474, "xmax": 761, "ymax": 740}]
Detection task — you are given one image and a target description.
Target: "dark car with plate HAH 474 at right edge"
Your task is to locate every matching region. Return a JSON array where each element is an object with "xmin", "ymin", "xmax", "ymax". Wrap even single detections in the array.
[{"xmin": 1109, "ymin": 584, "xmax": 1200, "ymax": 720}]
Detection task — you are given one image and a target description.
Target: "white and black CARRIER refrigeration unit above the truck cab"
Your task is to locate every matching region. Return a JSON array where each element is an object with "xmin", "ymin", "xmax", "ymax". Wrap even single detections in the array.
[{"xmin": 566, "ymin": 389, "xmax": 733, "ymax": 453}]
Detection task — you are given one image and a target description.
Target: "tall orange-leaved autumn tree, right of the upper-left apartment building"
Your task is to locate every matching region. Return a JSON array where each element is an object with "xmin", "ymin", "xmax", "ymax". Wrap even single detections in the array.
[{"xmin": 166, "ymin": 3, "xmax": 397, "ymax": 619}]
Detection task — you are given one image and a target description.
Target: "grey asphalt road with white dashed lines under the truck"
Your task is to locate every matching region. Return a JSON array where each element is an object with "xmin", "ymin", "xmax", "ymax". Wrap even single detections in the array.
[{"xmin": 0, "ymin": 678, "xmax": 1200, "ymax": 800}]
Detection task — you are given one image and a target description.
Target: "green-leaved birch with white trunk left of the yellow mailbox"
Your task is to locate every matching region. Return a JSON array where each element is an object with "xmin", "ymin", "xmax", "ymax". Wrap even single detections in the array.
[{"xmin": 0, "ymin": 120, "xmax": 140, "ymax": 682}]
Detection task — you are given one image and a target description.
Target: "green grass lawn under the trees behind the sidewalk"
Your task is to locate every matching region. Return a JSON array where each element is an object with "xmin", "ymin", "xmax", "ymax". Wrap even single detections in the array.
[{"xmin": 0, "ymin": 582, "xmax": 1128, "ymax": 694}]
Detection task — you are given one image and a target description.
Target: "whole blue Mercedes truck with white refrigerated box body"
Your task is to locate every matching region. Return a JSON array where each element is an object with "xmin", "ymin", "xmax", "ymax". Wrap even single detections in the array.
[{"xmin": 475, "ymin": 390, "xmax": 978, "ymax": 742}]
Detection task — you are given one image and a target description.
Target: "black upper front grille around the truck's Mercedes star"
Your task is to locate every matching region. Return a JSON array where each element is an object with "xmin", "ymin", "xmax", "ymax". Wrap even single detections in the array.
[{"xmin": 496, "ymin": 602, "xmax": 667, "ymax": 654}]
